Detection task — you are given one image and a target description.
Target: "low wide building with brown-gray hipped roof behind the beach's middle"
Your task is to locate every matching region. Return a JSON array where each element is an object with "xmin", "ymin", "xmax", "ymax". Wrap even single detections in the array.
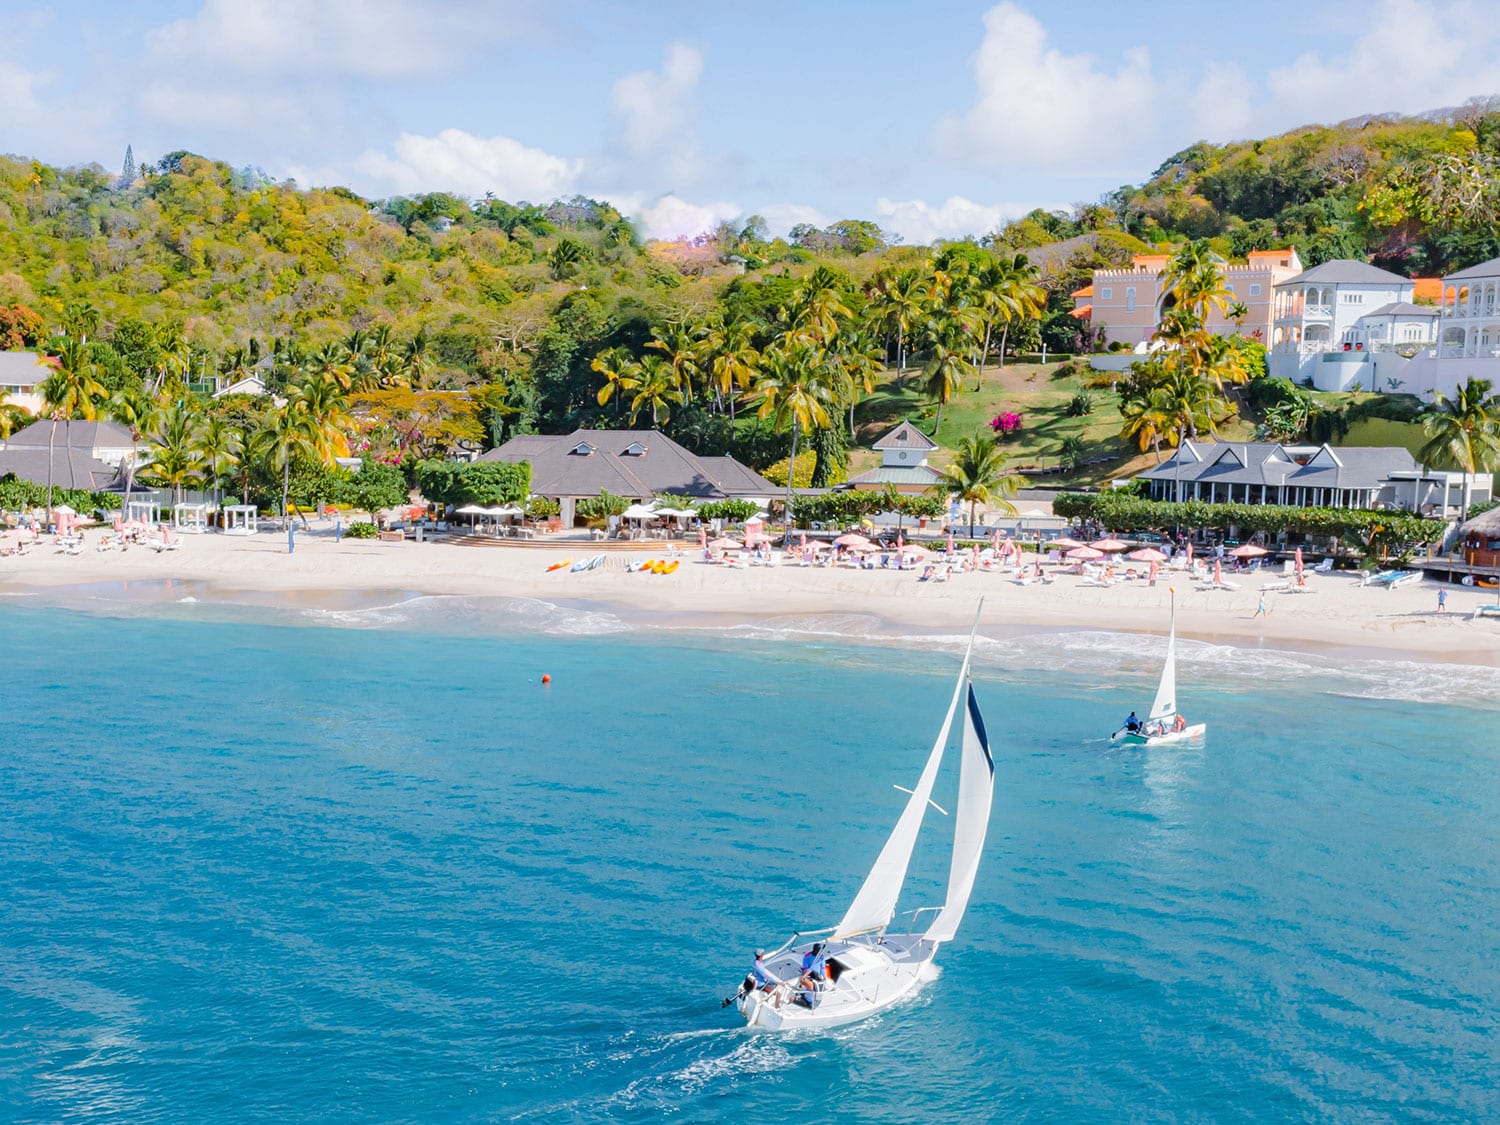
[{"xmin": 479, "ymin": 429, "xmax": 782, "ymax": 528}]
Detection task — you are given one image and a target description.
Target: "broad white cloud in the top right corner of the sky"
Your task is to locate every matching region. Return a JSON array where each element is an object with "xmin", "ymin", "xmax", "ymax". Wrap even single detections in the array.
[{"xmin": 1266, "ymin": 0, "xmax": 1500, "ymax": 128}]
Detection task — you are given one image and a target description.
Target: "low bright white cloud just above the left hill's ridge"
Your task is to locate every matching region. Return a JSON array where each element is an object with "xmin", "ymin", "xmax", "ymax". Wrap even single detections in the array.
[{"xmin": 354, "ymin": 129, "xmax": 584, "ymax": 201}]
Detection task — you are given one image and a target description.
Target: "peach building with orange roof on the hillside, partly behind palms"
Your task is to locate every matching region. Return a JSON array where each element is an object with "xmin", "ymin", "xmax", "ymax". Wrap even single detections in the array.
[{"xmin": 1073, "ymin": 248, "xmax": 1302, "ymax": 351}]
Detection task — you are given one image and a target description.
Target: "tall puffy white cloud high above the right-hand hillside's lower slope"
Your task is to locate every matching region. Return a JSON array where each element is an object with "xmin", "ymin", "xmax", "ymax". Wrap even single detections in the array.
[{"xmin": 936, "ymin": 0, "xmax": 1158, "ymax": 170}]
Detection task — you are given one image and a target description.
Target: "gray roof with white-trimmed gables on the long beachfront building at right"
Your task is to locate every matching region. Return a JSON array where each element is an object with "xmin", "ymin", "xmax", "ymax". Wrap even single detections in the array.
[{"xmin": 1140, "ymin": 441, "xmax": 1416, "ymax": 489}]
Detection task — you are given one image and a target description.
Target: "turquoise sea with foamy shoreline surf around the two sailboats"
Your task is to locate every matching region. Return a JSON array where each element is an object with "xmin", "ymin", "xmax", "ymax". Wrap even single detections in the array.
[{"xmin": 0, "ymin": 599, "xmax": 1500, "ymax": 1122}]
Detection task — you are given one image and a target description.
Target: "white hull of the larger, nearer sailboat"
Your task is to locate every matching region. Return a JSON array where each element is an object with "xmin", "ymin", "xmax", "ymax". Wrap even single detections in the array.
[{"xmin": 735, "ymin": 933, "xmax": 938, "ymax": 1031}]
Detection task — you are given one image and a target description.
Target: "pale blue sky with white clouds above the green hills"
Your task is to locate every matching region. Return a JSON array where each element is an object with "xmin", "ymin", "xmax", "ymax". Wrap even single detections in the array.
[{"xmin": 0, "ymin": 0, "xmax": 1500, "ymax": 242}]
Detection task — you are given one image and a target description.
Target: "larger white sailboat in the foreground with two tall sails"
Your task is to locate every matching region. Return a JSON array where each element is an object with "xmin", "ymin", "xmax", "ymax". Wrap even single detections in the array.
[{"xmin": 725, "ymin": 603, "xmax": 995, "ymax": 1031}]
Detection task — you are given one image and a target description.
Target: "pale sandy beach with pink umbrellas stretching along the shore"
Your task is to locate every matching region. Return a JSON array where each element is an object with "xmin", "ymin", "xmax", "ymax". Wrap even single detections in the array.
[{"xmin": 0, "ymin": 525, "xmax": 1500, "ymax": 666}]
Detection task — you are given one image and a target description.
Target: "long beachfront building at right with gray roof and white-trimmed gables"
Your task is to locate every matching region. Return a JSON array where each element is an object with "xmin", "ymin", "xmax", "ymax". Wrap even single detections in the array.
[{"xmin": 1136, "ymin": 441, "xmax": 1491, "ymax": 519}]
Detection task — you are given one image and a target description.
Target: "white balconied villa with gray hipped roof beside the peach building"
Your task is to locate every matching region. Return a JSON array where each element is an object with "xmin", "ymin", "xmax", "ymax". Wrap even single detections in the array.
[{"xmin": 1268, "ymin": 258, "xmax": 1439, "ymax": 390}]
